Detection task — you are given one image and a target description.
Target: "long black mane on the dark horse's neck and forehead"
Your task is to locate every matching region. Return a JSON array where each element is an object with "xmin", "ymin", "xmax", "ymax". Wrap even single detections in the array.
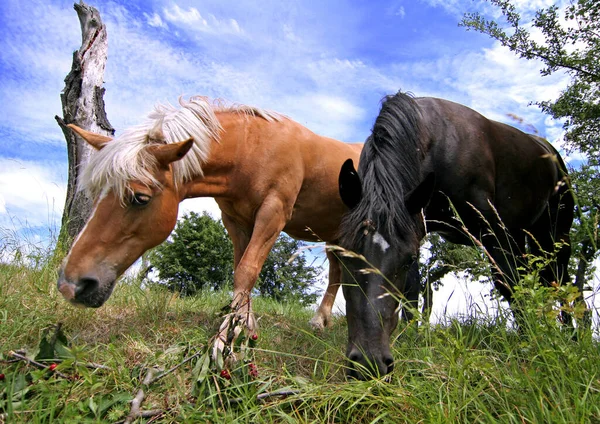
[{"xmin": 340, "ymin": 92, "xmax": 423, "ymax": 249}]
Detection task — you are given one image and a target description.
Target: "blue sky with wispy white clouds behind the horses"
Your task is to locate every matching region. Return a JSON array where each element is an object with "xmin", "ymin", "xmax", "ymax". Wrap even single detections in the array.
[{"xmin": 0, "ymin": 0, "xmax": 580, "ymax": 314}]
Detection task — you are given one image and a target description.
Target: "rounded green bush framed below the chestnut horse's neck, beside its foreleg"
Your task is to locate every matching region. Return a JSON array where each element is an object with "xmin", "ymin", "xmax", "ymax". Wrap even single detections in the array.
[{"xmin": 148, "ymin": 212, "xmax": 233, "ymax": 296}]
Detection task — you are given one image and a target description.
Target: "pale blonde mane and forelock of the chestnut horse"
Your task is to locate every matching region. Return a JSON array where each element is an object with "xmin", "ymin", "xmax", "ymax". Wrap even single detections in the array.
[{"xmin": 79, "ymin": 96, "xmax": 282, "ymax": 201}]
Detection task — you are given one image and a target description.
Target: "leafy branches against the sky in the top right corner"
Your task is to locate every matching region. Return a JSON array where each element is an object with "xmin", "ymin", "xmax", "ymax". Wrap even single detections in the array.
[{"xmin": 462, "ymin": 0, "xmax": 600, "ymax": 157}]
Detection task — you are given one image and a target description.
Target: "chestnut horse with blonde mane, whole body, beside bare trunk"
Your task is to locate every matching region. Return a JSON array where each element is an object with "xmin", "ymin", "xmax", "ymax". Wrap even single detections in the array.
[{"xmin": 58, "ymin": 97, "xmax": 362, "ymax": 331}]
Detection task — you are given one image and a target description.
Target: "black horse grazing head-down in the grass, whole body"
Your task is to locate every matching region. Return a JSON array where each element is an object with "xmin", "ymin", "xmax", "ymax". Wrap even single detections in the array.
[{"xmin": 339, "ymin": 93, "xmax": 574, "ymax": 378}]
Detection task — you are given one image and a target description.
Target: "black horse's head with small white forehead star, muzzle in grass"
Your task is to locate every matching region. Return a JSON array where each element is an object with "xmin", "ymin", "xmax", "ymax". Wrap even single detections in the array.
[{"xmin": 339, "ymin": 160, "xmax": 433, "ymax": 379}]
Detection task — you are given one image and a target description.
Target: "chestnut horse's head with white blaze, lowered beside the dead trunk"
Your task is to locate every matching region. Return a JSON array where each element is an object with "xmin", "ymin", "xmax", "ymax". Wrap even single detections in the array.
[{"xmin": 58, "ymin": 125, "xmax": 193, "ymax": 308}]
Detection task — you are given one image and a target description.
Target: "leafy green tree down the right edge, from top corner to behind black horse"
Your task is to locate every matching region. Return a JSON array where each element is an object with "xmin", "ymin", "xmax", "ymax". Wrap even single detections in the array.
[{"xmin": 461, "ymin": 0, "xmax": 600, "ymax": 296}]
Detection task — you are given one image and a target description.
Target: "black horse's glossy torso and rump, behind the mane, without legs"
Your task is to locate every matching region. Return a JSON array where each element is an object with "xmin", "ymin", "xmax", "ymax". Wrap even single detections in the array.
[{"xmin": 416, "ymin": 98, "xmax": 562, "ymax": 232}]
